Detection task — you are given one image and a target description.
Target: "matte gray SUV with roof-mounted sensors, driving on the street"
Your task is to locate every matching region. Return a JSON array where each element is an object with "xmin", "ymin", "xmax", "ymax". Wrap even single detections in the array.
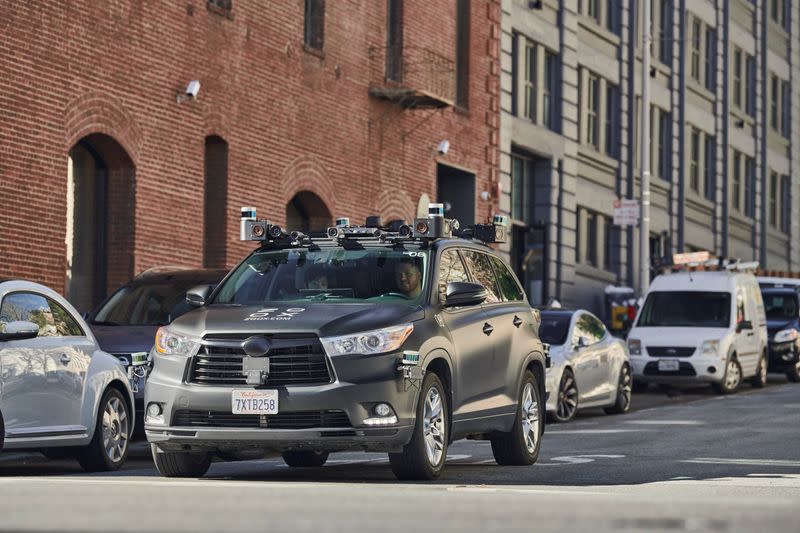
[{"xmin": 145, "ymin": 217, "xmax": 547, "ymax": 479}]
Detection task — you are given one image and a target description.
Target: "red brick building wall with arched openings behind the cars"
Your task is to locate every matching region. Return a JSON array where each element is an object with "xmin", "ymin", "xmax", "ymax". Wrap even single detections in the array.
[{"xmin": 0, "ymin": 0, "xmax": 500, "ymax": 304}]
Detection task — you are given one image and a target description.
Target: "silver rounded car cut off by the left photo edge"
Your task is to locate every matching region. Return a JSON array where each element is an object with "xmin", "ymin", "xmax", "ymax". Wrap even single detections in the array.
[{"xmin": 0, "ymin": 279, "xmax": 134, "ymax": 471}]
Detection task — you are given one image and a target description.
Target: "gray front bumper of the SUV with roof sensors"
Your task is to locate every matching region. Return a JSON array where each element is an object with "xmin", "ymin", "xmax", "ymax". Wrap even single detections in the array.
[{"xmin": 145, "ymin": 354, "xmax": 419, "ymax": 451}]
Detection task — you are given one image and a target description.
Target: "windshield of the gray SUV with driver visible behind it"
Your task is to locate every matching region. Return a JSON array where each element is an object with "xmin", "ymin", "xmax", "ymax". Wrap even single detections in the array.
[{"xmin": 212, "ymin": 247, "xmax": 428, "ymax": 305}]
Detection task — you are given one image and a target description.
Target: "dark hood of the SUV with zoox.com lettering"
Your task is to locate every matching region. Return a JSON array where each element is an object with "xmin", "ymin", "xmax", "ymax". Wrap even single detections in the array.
[{"xmin": 170, "ymin": 302, "xmax": 425, "ymax": 337}]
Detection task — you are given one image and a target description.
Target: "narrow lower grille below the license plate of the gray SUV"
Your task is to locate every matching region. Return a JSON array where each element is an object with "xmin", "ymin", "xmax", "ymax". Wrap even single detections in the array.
[{"xmin": 172, "ymin": 410, "xmax": 351, "ymax": 429}]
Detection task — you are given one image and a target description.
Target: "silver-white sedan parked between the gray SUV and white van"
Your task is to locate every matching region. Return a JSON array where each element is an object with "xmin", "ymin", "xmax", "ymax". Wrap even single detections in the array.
[{"xmin": 539, "ymin": 309, "xmax": 632, "ymax": 422}]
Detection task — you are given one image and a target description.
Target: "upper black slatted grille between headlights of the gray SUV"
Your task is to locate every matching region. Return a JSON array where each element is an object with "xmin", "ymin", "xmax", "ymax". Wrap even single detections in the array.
[{"xmin": 189, "ymin": 335, "xmax": 332, "ymax": 387}]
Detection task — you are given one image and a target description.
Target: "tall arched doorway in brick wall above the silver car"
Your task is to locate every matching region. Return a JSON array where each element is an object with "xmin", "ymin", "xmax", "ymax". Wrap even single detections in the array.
[{"xmin": 66, "ymin": 133, "xmax": 136, "ymax": 312}]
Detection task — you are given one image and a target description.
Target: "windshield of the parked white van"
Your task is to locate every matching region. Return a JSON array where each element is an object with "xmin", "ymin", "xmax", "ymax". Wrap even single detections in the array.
[{"xmin": 636, "ymin": 291, "xmax": 731, "ymax": 328}]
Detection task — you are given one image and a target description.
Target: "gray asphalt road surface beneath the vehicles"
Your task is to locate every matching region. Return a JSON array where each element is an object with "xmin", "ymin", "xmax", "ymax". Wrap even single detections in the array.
[{"xmin": 0, "ymin": 378, "xmax": 800, "ymax": 532}]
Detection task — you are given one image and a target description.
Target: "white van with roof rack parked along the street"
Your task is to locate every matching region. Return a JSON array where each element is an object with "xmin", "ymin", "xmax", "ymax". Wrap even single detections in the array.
[{"xmin": 628, "ymin": 271, "xmax": 768, "ymax": 393}]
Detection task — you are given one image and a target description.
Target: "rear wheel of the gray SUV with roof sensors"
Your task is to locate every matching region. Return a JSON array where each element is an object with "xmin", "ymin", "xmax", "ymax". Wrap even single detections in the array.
[{"xmin": 492, "ymin": 370, "xmax": 544, "ymax": 466}]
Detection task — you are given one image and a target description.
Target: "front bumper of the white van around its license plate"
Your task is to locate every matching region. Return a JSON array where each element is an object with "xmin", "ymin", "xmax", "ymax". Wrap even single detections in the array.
[{"xmin": 631, "ymin": 350, "xmax": 726, "ymax": 384}]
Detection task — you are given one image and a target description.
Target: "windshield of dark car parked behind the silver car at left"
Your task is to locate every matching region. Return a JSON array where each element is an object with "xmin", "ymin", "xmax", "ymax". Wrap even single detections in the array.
[{"xmin": 92, "ymin": 280, "xmax": 203, "ymax": 326}]
